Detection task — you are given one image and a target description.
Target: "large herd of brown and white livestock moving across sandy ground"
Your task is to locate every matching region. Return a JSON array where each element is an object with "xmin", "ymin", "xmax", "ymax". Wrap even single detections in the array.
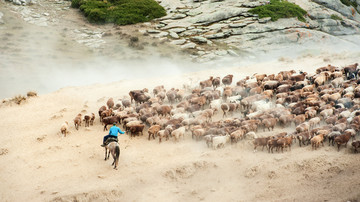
[{"xmin": 61, "ymin": 63, "xmax": 360, "ymax": 153}]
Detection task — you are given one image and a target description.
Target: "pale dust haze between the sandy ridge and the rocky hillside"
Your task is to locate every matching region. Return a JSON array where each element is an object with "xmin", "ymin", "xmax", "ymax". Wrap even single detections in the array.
[{"xmin": 0, "ymin": 6, "xmax": 360, "ymax": 98}]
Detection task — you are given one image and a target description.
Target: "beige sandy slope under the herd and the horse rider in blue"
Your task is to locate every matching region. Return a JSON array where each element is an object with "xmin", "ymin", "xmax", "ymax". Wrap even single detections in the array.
[{"xmin": 0, "ymin": 54, "xmax": 360, "ymax": 201}]
